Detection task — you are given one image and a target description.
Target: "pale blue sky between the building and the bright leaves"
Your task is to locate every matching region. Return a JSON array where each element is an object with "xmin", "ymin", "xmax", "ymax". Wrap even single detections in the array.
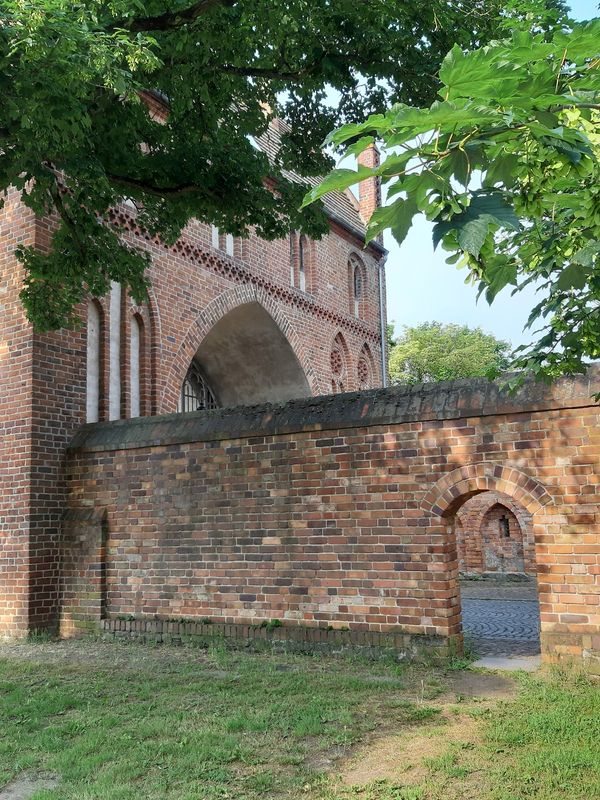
[{"xmin": 385, "ymin": 0, "xmax": 599, "ymax": 346}]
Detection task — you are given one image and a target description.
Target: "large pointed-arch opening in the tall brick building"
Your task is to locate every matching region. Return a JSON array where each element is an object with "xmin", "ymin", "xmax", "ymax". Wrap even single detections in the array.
[{"xmin": 179, "ymin": 302, "xmax": 311, "ymax": 411}]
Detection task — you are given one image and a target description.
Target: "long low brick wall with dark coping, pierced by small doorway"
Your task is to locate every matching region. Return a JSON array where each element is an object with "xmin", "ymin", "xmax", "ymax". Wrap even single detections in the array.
[{"xmin": 63, "ymin": 367, "xmax": 600, "ymax": 668}]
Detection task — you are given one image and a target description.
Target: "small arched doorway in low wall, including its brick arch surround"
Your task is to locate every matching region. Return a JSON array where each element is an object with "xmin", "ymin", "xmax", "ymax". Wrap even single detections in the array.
[{"xmin": 424, "ymin": 462, "xmax": 553, "ymax": 666}]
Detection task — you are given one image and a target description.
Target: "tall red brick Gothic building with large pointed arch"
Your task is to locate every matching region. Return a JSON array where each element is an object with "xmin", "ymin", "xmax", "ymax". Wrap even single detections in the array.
[{"xmin": 0, "ymin": 141, "xmax": 385, "ymax": 635}]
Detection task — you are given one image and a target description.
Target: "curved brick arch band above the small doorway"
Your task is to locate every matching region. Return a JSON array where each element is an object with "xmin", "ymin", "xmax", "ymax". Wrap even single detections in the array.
[{"xmin": 421, "ymin": 461, "xmax": 552, "ymax": 517}]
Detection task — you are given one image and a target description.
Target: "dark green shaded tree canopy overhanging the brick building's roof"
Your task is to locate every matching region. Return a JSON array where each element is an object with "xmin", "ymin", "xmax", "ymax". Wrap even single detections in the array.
[{"xmin": 0, "ymin": 0, "xmax": 502, "ymax": 328}]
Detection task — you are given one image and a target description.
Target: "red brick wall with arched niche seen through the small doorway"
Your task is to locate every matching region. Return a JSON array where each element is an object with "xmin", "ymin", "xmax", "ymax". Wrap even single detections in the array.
[{"xmin": 456, "ymin": 492, "xmax": 536, "ymax": 575}]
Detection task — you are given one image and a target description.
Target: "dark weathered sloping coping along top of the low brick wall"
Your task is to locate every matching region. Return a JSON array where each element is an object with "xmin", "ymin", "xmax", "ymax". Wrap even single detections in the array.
[{"xmin": 69, "ymin": 363, "xmax": 600, "ymax": 451}]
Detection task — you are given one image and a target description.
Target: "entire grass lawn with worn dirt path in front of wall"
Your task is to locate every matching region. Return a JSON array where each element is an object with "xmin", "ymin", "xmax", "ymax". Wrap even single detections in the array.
[{"xmin": 0, "ymin": 641, "xmax": 600, "ymax": 800}]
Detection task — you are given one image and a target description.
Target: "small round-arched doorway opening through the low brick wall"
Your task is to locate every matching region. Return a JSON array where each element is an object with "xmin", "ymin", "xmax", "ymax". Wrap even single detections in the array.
[{"xmin": 453, "ymin": 490, "xmax": 540, "ymax": 658}]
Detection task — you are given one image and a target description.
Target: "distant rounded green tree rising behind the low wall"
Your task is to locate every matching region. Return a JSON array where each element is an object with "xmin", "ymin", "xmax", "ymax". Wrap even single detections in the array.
[{"xmin": 389, "ymin": 322, "xmax": 510, "ymax": 383}]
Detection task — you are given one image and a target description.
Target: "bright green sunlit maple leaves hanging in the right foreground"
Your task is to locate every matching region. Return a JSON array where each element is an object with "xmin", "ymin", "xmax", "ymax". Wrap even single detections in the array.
[{"xmin": 305, "ymin": 8, "xmax": 600, "ymax": 380}]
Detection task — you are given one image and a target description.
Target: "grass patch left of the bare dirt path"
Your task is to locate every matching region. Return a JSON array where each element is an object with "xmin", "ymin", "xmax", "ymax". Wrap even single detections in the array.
[{"xmin": 0, "ymin": 642, "xmax": 448, "ymax": 800}]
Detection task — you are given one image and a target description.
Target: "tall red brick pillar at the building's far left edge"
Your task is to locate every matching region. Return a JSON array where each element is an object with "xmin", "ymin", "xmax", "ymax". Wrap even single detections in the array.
[{"xmin": 0, "ymin": 197, "xmax": 86, "ymax": 637}]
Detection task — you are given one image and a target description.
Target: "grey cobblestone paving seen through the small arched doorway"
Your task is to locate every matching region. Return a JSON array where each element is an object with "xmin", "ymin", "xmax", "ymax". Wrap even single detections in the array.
[{"xmin": 462, "ymin": 587, "xmax": 540, "ymax": 657}]
